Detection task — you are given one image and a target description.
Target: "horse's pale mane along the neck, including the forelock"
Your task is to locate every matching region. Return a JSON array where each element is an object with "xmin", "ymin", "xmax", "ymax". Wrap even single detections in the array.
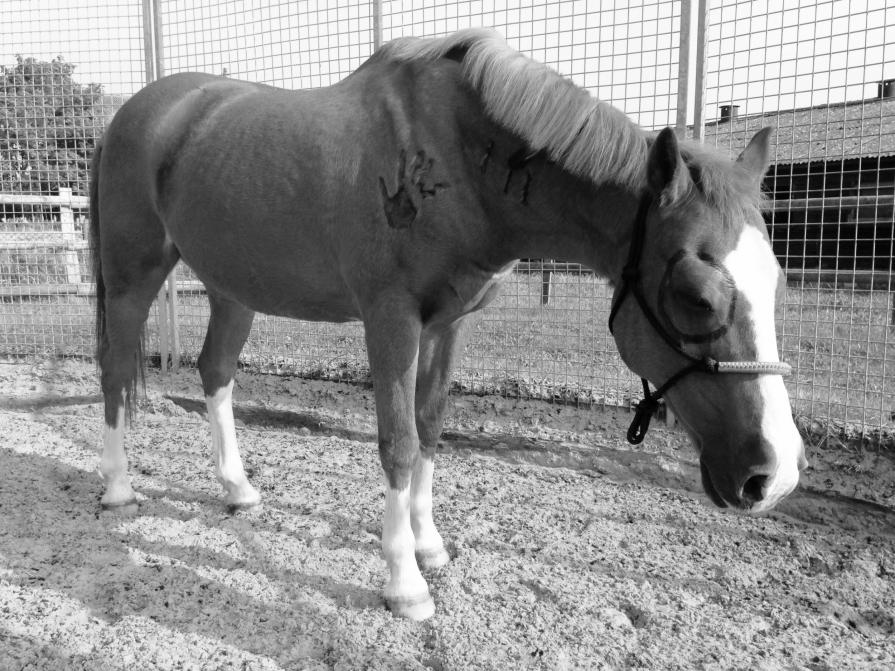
[{"xmin": 380, "ymin": 28, "xmax": 760, "ymax": 218}]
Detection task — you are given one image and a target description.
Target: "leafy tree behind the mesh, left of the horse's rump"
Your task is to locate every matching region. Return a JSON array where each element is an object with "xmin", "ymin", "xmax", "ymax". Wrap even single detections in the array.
[{"xmin": 0, "ymin": 56, "xmax": 106, "ymax": 200}]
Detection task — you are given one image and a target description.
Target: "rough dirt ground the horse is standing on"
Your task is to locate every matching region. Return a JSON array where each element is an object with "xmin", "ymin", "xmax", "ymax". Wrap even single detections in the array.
[{"xmin": 0, "ymin": 361, "xmax": 895, "ymax": 671}]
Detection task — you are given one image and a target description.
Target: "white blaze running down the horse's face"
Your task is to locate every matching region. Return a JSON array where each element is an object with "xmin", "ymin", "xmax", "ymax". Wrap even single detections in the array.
[{"xmin": 723, "ymin": 225, "xmax": 802, "ymax": 511}]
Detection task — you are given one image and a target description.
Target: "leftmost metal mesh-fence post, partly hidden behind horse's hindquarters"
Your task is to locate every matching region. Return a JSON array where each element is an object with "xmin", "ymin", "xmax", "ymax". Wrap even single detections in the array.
[{"xmin": 143, "ymin": 0, "xmax": 180, "ymax": 372}]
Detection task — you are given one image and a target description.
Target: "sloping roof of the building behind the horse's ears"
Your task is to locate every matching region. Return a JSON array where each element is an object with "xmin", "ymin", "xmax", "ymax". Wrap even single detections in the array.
[{"xmin": 704, "ymin": 98, "xmax": 895, "ymax": 163}]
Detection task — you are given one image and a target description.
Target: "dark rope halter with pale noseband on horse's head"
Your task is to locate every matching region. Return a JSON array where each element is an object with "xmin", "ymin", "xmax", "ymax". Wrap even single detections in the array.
[{"xmin": 609, "ymin": 194, "xmax": 792, "ymax": 445}]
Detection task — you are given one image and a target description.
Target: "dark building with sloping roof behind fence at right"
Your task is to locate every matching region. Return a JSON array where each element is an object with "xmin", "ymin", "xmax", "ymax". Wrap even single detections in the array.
[{"xmin": 705, "ymin": 79, "xmax": 895, "ymax": 289}]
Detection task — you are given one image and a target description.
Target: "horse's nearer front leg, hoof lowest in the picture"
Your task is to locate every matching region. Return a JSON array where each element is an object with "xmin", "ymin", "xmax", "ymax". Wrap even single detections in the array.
[{"xmin": 364, "ymin": 297, "xmax": 435, "ymax": 620}]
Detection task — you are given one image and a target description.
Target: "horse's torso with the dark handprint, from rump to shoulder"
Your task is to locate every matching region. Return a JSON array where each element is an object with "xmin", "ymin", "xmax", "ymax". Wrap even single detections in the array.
[{"xmin": 95, "ymin": 58, "xmax": 516, "ymax": 321}]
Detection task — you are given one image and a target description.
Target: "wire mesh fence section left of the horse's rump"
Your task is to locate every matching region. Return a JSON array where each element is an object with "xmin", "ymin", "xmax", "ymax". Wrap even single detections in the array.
[{"xmin": 0, "ymin": 0, "xmax": 146, "ymax": 356}]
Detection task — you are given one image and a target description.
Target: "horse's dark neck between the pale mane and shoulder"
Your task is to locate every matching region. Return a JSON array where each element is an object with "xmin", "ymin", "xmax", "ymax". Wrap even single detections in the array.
[{"xmin": 372, "ymin": 54, "xmax": 638, "ymax": 278}]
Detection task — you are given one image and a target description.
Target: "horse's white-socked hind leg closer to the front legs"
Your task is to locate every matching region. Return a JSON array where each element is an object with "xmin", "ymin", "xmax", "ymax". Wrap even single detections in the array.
[{"xmin": 193, "ymin": 295, "xmax": 261, "ymax": 508}]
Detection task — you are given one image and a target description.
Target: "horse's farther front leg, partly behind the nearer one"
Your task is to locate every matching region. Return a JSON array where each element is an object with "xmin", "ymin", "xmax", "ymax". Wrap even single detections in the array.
[{"xmin": 410, "ymin": 321, "xmax": 462, "ymax": 569}]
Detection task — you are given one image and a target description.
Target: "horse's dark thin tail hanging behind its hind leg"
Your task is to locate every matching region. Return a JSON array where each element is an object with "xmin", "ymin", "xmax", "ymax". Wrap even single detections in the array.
[{"xmin": 89, "ymin": 140, "xmax": 146, "ymax": 420}]
